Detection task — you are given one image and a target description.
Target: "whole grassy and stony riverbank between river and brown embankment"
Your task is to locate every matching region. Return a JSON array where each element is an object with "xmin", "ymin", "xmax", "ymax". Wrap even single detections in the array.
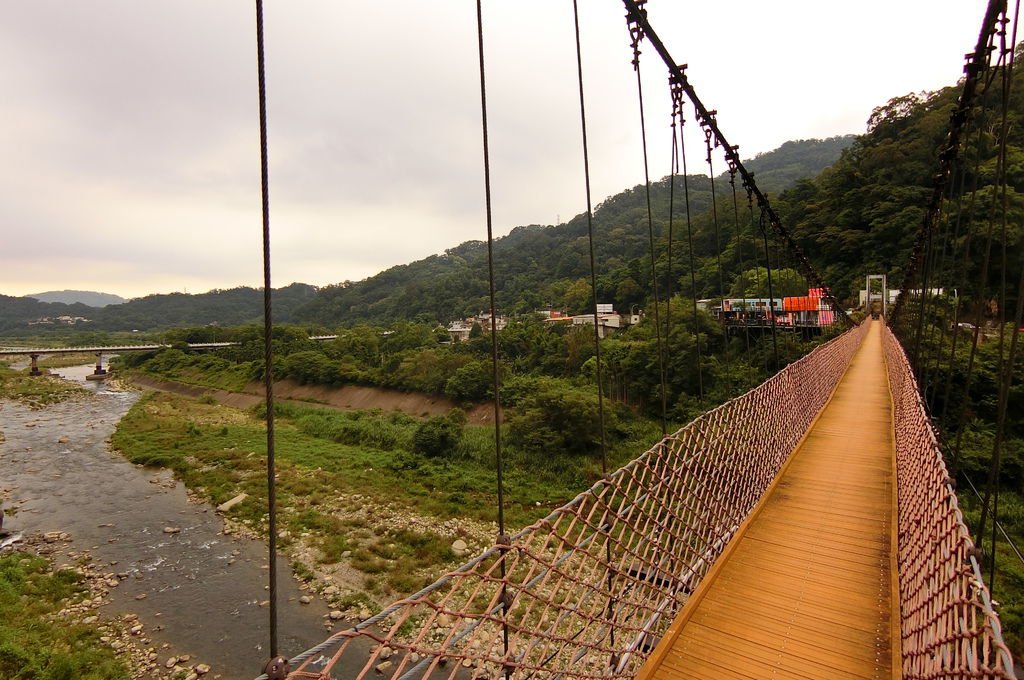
[{"xmin": 112, "ymin": 392, "xmax": 655, "ymax": 603}]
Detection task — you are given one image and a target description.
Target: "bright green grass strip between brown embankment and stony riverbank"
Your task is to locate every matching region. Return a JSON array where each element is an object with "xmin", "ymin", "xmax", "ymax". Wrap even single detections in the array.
[{"xmin": 112, "ymin": 393, "xmax": 657, "ymax": 524}]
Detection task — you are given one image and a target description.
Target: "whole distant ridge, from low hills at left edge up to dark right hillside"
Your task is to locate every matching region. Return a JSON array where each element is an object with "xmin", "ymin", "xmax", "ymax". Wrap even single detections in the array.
[{"xmin": 0, "ymin": 135, "xmax": 856, "ymax": 335}]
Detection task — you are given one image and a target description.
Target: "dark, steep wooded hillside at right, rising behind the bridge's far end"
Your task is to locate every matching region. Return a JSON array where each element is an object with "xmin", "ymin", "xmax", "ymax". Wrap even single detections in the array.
[{"xmin": 777, "ymin": 82, "xmax": 1024, "ymax": 308}]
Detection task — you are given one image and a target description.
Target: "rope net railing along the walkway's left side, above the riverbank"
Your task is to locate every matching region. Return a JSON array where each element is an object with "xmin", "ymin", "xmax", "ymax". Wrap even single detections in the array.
[{"xmin": 274, "ymin": 319, "xmax": 866, "ymax": 680}]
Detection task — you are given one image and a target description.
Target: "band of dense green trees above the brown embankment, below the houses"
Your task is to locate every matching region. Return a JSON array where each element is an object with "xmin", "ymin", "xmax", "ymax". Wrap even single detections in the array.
[{"xmin": 118, "ymin": 307, "xmax": 798, "ymax": 426}]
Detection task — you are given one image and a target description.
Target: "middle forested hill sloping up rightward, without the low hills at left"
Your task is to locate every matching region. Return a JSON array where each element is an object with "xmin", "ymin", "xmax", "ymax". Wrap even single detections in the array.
[{"xmin": 296, "ymin": 136, "xmax": 853, "ymax": 325}]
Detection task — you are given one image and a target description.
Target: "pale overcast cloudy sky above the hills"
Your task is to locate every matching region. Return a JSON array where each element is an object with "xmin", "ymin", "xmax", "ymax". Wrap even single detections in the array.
[{"xmin": 0, "ymin": 0, "xmax": 985, "ymax": 297}]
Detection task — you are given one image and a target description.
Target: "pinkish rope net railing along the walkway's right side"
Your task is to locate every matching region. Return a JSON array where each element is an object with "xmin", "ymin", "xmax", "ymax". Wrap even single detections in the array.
[{"xmin": 884, "ymin": 328, "xmax": 1016, "ymax": 678}]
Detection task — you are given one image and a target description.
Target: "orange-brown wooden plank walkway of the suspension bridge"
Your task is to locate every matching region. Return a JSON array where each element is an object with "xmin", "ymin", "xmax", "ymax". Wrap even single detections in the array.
[{"xmin": 637, "ymin": 323, "xmax": 900, "ymax": 680}]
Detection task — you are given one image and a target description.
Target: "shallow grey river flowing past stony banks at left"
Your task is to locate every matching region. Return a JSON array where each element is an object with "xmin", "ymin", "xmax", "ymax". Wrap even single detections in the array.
[{"xmin": 0, "ymin": 366, "xmax": 333, "ymax": 680}]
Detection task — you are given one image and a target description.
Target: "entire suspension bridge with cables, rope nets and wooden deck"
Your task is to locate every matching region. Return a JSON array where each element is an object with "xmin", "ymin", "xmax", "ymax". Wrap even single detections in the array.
[{"xmin": 234, "ymin": 0, "xmax": 1024, "ymax": 680}]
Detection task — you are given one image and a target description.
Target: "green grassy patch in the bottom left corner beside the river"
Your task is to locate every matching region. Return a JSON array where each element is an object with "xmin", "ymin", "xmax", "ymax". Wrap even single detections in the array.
[{"xmin": 0, "ymin": 552, "xmax": 129, "ymax": 680}]
